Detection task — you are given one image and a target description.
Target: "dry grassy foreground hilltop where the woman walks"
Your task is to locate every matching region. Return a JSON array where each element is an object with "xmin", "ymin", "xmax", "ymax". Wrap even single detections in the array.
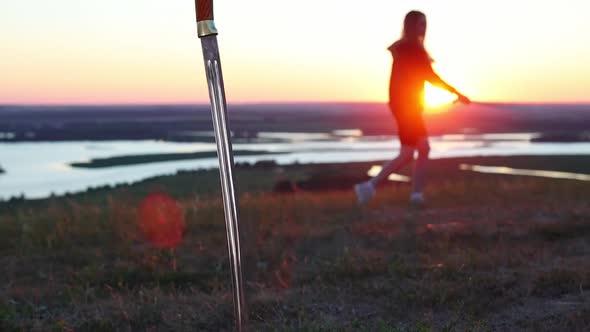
[{"xmin": 0, "ymin": 156, "xmax": 590, "ymax": 331}]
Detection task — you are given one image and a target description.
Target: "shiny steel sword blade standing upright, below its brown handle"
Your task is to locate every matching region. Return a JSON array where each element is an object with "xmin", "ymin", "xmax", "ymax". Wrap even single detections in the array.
[{"xmin": 201, "ymin": 35, "xmax": 247, "ymax": 331}]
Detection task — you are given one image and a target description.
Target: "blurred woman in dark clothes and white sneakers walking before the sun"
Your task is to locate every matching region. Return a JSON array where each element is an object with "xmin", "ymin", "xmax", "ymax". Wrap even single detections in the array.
[{"xmin": 354, "ymin": 11, "xmax": 470, "ymax": 204}]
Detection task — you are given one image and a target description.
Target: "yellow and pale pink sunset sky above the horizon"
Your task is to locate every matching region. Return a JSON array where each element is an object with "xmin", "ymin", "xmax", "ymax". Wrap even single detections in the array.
[{"xmin": 0, "ymin": 0, "xmax": 590, "ymax": 104}]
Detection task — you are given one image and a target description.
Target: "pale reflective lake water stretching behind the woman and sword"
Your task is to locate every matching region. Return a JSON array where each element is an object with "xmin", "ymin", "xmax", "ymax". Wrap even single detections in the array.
[{"xmin": 0, "ymin": 129, "xmax": 590, "ymax": 199}]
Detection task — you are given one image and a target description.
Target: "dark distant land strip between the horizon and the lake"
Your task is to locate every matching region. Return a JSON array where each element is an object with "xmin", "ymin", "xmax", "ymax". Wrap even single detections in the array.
[{"xmin": 0, "ymin": 103, "xmax": 590, "ymax": 142}]
